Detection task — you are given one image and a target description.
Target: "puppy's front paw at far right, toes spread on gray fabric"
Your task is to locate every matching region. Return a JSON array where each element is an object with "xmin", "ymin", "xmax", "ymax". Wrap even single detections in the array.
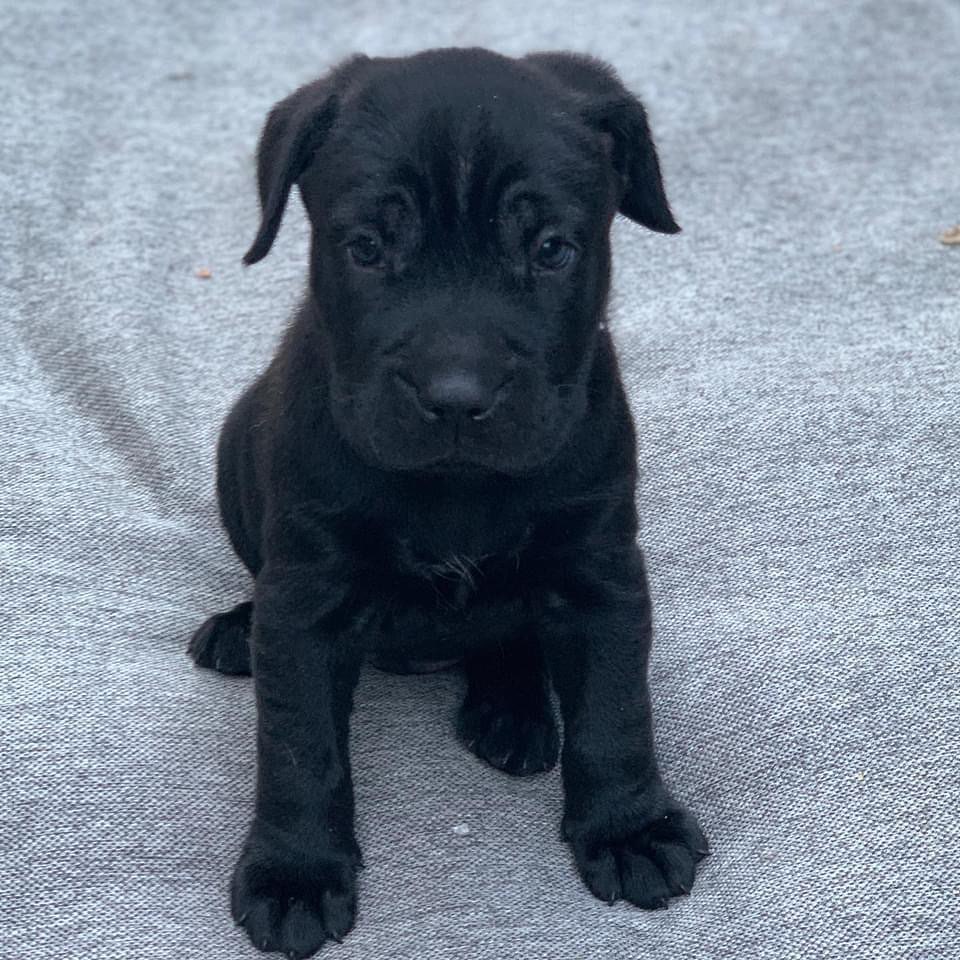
[{"xmin": 566, "ymin": 805, "xmax": 709, "ymax": 910}]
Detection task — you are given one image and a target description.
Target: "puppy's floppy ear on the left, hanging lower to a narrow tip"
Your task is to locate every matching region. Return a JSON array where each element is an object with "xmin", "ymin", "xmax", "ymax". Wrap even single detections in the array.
[{"xmin": 243, "ymin": 56, "xmax": 369, "ymax": 265}]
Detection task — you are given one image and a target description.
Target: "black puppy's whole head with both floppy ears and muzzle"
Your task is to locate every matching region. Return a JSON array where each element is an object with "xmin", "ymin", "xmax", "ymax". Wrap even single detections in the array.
[{"xmin": 244, "ymin": 49, "xmax": 679, "ymax": 476}]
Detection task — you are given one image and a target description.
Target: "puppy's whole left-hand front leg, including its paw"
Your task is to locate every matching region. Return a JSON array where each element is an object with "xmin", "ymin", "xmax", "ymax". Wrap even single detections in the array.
[{"xmin": 231, "ymin": 565, "xmax": 361, "ymax": 957}]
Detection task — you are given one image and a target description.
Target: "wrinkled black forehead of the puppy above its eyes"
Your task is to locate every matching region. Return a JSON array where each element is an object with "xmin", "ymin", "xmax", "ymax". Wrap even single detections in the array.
[{"xmin": 318, "ymin": 64, "xmax": 605, "ymax": 228}]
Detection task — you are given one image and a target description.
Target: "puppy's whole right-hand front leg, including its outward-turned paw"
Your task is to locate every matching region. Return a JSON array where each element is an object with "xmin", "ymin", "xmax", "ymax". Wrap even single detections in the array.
[{"xmin": 544, "ymin": 549, "xmax": 707, "ymax": 909}]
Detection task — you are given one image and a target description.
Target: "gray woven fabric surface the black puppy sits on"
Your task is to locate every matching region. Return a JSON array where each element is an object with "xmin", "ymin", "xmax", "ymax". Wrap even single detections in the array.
[{"xmin": 0, "ymin": 0, "xmax": 960, "ymax": 960}]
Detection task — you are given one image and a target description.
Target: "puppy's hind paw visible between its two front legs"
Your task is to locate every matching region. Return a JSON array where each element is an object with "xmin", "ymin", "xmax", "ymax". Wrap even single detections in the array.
[{"xmin": 457, "ymin": 700, "xmax": 560, "ymax": 777}]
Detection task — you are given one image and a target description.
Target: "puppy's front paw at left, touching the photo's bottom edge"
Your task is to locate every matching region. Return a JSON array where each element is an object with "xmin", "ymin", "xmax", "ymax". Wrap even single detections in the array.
[{"xmin": 230, "ymin": 834, "xmax": 359, "ymax": 960}]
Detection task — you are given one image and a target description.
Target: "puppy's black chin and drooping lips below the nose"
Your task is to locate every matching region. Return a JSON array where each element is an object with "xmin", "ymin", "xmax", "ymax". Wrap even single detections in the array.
[{"xmin": 331, "ymin": 378, "xmax": 586, "ymax": 478}]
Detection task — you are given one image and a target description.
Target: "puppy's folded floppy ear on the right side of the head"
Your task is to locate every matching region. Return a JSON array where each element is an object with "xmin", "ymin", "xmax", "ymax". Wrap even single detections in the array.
[{"xmin": 525, "ymin": 53, "xmax": 680, "ymax": 233}]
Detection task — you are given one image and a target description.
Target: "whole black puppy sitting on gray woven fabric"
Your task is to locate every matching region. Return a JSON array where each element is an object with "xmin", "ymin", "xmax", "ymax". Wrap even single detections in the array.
[{"xmin": 190, "ymin": 50, "xmax": 706, "ymax": 957}]
